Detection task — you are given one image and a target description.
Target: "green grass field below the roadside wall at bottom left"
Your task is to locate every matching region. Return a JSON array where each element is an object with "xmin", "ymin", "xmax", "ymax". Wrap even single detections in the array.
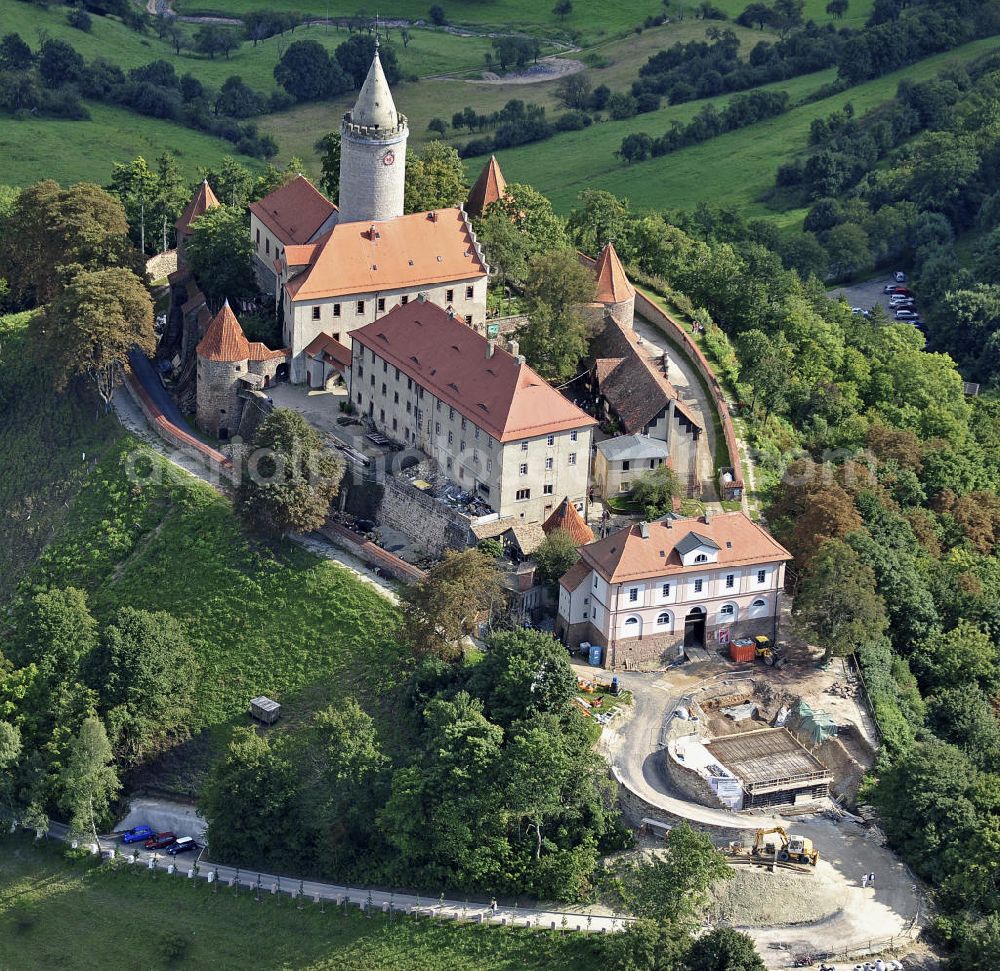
[{"xmin": 0, "ymin": 837, "xmax": 601, "ymax": 971}]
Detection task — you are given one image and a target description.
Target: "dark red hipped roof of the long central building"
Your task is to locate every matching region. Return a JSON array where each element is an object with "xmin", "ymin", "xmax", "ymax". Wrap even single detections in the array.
[{"xmin": 351, "ymin": 300, "xmax": 596, "ymax": 444}]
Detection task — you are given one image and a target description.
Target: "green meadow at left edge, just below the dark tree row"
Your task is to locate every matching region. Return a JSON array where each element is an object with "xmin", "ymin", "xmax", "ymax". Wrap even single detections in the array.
[{"xmin": 0, "ymin": 101, "xmax": 262, "ymax": 185}]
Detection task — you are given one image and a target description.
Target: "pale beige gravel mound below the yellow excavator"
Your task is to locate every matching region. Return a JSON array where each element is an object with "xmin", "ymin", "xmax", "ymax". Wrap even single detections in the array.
[{"xmin": 707, "ymin": 866, "xmax": 847, "ymax": 927}]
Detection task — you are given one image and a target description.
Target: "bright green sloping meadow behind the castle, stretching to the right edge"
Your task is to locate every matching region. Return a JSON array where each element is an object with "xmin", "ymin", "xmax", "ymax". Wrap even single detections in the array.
[{"xmin": 468, "ymin": 38, "xmax": 1000, "ymax": 222}]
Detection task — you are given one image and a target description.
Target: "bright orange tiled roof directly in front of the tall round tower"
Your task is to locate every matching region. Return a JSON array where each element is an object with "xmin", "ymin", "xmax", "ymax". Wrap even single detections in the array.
[{"xmin": 282, "ymin": 207, "xmax": 488, "ymax": 300}]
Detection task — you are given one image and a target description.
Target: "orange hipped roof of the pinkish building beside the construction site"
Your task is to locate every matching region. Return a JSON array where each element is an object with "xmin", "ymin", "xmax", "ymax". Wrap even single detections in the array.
[{"xmin": 580, "ymin": 512, "xmax": 792, "ymax": 583}]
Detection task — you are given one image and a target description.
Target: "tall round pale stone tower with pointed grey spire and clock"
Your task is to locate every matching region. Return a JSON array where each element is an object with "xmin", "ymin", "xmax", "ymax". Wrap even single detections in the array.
[{"xmin": 337, "ymin": 39, "xmax": 410, "ymax": 223}]
